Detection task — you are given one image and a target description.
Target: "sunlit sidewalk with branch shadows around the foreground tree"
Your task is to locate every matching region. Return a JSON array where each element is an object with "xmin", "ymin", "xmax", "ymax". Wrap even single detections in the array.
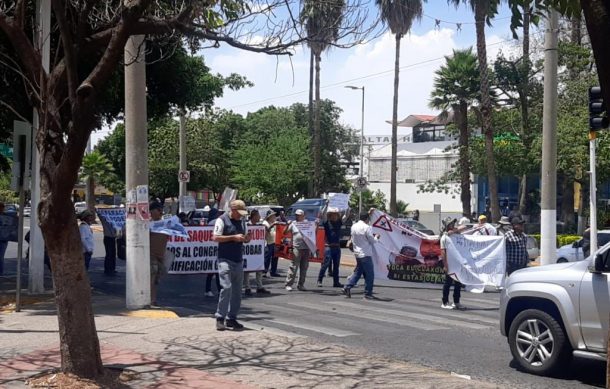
[{"xmin": 0, "ymin": 292, "xmax": 504, "ymax": 389}]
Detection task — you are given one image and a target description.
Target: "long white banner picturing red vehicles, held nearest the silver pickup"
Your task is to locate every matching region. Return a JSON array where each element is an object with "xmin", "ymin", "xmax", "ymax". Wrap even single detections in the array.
[{"xmin": 371, "ymin": 210, "xmax": 506, "ymax": 291}]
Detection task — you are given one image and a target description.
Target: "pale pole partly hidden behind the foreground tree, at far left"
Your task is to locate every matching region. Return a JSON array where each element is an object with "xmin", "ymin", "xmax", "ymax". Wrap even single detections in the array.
[{"xmin": 28, "ymin": 0, "xmax": 51, "ymax": 294}]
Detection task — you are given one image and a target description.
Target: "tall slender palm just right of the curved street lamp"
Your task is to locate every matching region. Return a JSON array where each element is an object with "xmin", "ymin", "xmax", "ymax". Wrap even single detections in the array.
[{"xmin": 375, "ymin": 0, "xmax": 423, "ymax": 216}]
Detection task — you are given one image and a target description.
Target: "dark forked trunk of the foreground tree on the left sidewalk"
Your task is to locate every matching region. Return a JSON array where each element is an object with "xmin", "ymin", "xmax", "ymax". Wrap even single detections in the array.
[{"xmin": 36, "ymin": 113, "xmax": 103, "ymax": 378}]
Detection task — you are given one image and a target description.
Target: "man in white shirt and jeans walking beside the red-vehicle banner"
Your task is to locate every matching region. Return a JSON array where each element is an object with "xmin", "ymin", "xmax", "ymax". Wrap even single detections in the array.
[{"xmin": 343, "ymin": 213, "xmax": 378, "ymax": 299}]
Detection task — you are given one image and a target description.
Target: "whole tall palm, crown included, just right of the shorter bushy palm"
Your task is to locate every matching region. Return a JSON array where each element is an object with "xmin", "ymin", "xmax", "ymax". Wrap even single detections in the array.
[{"xmin": 447, "ymin": 0, "xmax": 500, "ymax": 221}]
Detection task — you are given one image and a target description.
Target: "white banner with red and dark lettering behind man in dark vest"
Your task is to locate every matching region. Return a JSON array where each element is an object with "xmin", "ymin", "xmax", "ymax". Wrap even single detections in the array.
[{"xmin": 167, "ymin": 226, "xmax": 266, "ymax": 274}]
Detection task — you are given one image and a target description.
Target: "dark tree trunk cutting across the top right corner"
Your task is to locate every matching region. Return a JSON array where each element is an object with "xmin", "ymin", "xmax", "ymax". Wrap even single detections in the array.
[{"xmin": 580, "ymin": 0, "xmax": 610, "ymax": 109}]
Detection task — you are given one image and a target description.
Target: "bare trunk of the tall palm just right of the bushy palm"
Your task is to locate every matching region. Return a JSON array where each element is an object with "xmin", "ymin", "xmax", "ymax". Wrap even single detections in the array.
[{"xmin": 475, "ymin": 5, "xmax": 500, "ymax": 222}]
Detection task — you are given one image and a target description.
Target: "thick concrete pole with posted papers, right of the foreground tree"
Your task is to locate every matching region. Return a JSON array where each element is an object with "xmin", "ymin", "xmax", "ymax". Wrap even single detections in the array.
[{"xmin": 124, "ymin": 35, "xmax": 150, "ymax": 309}]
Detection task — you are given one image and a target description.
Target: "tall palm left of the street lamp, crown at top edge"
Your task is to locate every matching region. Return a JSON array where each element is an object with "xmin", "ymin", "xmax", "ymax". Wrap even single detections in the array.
[{"xmin": 301, "ymin": 0, "xmax": 345, "ymax": 196}]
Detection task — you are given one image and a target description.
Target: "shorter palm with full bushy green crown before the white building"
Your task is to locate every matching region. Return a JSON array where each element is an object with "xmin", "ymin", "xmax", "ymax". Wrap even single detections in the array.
[{"xmin": 429, "ymin": 48, "xmax": 480, "ymax": 216}]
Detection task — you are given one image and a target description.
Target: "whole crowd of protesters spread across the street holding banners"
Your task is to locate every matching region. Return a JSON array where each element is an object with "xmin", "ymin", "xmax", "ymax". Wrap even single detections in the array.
[{"xmin": 38, "ymin": 200, "xmax": 529, "ymax": 331}]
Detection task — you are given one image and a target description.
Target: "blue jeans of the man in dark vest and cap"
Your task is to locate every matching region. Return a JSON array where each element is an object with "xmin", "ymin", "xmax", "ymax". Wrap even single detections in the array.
[{"xmin": 215, "ymin": 258, "xmax": 244, "ymax": 319}]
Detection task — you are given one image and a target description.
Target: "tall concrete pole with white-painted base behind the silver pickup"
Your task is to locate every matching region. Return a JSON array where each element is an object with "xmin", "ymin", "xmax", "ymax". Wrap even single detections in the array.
[{"xmin": 540, "ymin": 10, "xmax": 559, "ymax": 265}]
